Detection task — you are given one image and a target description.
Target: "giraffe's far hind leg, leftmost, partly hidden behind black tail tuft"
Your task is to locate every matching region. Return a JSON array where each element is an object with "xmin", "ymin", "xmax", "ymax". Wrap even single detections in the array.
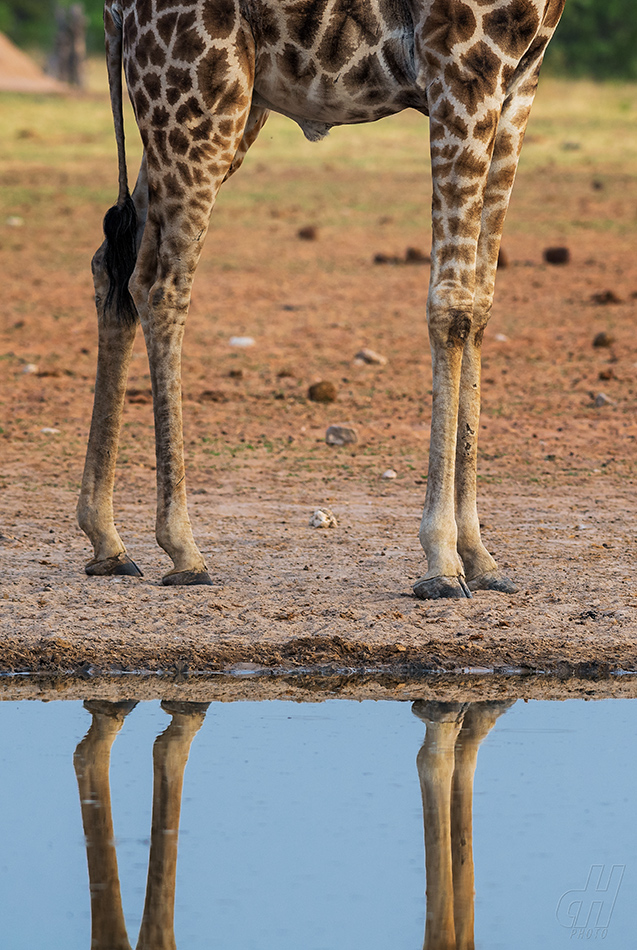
[{"xmin": 77, "ymin": 161, "xmax": 148, "ymax": 577}]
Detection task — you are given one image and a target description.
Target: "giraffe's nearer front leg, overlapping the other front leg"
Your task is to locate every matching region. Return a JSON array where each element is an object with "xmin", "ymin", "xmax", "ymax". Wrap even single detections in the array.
[{"xmin": 413, "ymin": 102, "xmax": 498, "ymax": 599}]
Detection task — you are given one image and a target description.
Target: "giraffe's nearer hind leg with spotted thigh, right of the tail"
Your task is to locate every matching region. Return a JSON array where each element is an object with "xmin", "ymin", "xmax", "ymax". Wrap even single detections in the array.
[{"xmin": 129, "ymin": 26, "xmax": 254, "ymax": 585}]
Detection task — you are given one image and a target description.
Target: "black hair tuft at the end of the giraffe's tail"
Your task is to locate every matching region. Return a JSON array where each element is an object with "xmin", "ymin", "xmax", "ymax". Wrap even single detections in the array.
[{"xmin": 104, "ymin": 194, "xmax": 137, "ymax": 324}]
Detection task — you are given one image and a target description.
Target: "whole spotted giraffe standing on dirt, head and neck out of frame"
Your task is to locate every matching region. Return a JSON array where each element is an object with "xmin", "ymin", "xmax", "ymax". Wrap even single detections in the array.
[{"xmin": 77, "ymin": 0, "xmax": 565, "ymax": 599}]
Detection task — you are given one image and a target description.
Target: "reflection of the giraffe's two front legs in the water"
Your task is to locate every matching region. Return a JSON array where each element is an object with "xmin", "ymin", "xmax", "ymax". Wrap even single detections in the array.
[{"xmin": 412, "ymin": 701, "xmax": 513, "ymax": 950}]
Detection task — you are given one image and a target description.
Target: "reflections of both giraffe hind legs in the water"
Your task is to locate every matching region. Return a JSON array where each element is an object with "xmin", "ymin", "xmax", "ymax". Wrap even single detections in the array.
[{"xmin": 73, "ymin": 701, "xmax": 209, "ymax": 950}]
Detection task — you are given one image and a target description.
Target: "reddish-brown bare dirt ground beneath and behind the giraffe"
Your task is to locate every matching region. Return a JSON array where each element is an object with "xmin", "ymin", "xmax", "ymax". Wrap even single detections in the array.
[{"xmin": 0, "ymin": 80, "xmax": 637, "ymax": 676}]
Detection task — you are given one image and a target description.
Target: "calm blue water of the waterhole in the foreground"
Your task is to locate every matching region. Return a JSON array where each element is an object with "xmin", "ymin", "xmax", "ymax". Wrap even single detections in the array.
[{"xmin": 0, "ymin": 700, "xmax": 637, "ymax": 950}]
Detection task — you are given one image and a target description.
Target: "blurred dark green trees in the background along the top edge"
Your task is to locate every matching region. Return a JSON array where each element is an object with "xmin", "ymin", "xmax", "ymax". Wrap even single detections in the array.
[{"xmin": 0, "ymin": 0, "xmax": 637, "ymax": 80}]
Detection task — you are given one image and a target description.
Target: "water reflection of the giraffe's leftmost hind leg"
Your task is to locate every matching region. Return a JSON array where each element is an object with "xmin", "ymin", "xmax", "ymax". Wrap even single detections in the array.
[{"xmin": 73, "ymin": 701, "xmax": 137, "ymax": 950}]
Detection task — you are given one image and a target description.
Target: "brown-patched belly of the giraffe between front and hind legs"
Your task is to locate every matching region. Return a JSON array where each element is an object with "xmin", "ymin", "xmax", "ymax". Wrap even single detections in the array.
[{"xmin": 248, "ymin": 0, "xmax": 426, "ymax": 138}]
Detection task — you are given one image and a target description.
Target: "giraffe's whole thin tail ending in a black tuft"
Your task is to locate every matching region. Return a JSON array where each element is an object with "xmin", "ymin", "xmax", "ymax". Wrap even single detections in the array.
[{"xmin": 104, "ymin": 0, "xmax": 137, "ymax": 323}]
